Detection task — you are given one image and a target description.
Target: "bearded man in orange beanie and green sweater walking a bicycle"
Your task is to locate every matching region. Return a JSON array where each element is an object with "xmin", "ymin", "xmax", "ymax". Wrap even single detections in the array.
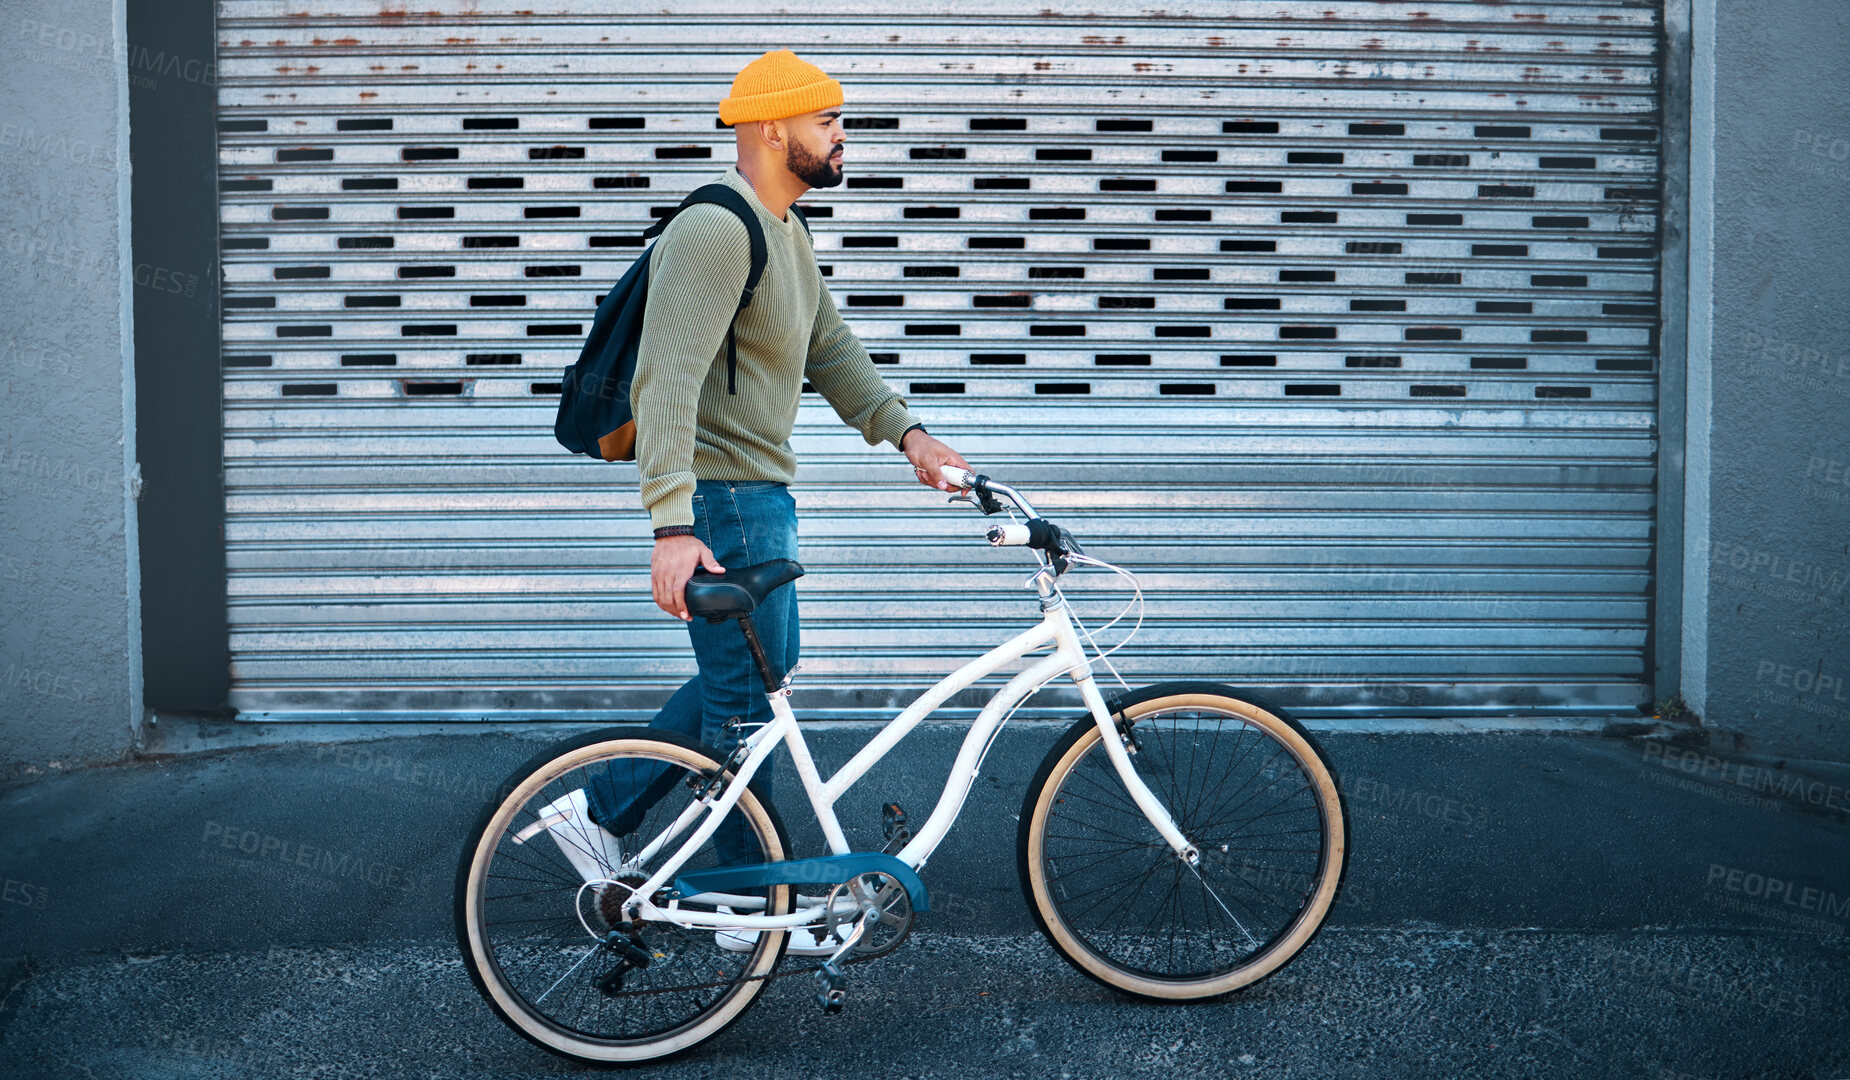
[{"xmin": 542, "ymin": 50, "xmax": 969, "ymax": 939}]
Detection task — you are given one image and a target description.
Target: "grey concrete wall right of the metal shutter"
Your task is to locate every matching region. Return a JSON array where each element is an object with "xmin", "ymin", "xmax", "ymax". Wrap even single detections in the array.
[{"xmin": 1685, "ymin": 0, "xmax": 1850, "ymax": 758}]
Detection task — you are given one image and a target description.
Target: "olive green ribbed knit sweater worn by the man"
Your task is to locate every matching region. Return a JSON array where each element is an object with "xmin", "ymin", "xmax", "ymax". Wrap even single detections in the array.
[{"xmin": 629, "ymin": 166, "xmax": 918, "ymax": 529}]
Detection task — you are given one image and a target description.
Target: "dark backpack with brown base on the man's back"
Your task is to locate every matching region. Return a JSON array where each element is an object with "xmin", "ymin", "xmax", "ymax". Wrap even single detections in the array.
[{"xmin": 553, "ymin": 183, "xmax": 808, "ymax": 460}]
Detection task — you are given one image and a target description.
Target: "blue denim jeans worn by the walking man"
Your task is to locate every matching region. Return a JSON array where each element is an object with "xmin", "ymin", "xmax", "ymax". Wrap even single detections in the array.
[{"xmin": 586, "ymin": 481, "xmax": 799, "ymax": 865}]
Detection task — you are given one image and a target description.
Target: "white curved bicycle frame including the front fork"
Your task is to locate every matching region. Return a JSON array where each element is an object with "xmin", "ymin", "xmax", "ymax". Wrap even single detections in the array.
[{"xmin": 625, "ymin": 573, "xmax": 1199, "ymax": 930}]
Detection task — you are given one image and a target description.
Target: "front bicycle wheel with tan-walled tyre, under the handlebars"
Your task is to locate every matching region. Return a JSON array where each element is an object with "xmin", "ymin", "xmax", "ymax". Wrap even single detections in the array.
[{"xmin": 1018, "ymin": 682, "xmax": 1349, "ymax": 1000}]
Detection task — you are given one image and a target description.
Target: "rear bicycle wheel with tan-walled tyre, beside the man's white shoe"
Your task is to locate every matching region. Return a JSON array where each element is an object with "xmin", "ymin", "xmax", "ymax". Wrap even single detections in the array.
[{"xmin": 455, "ymin": 729, "xmax": 794, "ymax": 1063}]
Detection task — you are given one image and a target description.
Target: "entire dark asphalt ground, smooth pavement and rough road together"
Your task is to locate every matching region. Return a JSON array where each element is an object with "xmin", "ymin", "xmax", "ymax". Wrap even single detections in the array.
[{"xmin": 0, "ymin": 725, "xmax": 1850, "ymax": 1080}]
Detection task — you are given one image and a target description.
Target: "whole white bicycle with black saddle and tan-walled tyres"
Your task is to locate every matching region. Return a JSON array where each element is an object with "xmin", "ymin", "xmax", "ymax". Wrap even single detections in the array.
[{"xmin": 455, "ymin": 468, "xmax": 1349, "ymax": 1063}]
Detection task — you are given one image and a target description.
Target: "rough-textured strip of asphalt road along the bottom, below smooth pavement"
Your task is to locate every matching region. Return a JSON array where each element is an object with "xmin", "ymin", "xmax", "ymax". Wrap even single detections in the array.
[{"xmin": 0, "ymin": 930, "xmax": 1850, "ymax": 1080}]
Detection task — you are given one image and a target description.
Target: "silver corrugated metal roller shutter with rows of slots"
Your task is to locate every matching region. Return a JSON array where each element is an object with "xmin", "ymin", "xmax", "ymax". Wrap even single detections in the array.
[{"xmin": 218, "ymin": 0, "xmax": 1659, "ymax": 716}]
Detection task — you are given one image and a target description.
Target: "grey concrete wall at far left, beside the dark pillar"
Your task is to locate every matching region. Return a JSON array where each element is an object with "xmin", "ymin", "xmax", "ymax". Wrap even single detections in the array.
[{"xmin": 0, "ymin": 0, "xmax": 140, "ymax": 773}]
